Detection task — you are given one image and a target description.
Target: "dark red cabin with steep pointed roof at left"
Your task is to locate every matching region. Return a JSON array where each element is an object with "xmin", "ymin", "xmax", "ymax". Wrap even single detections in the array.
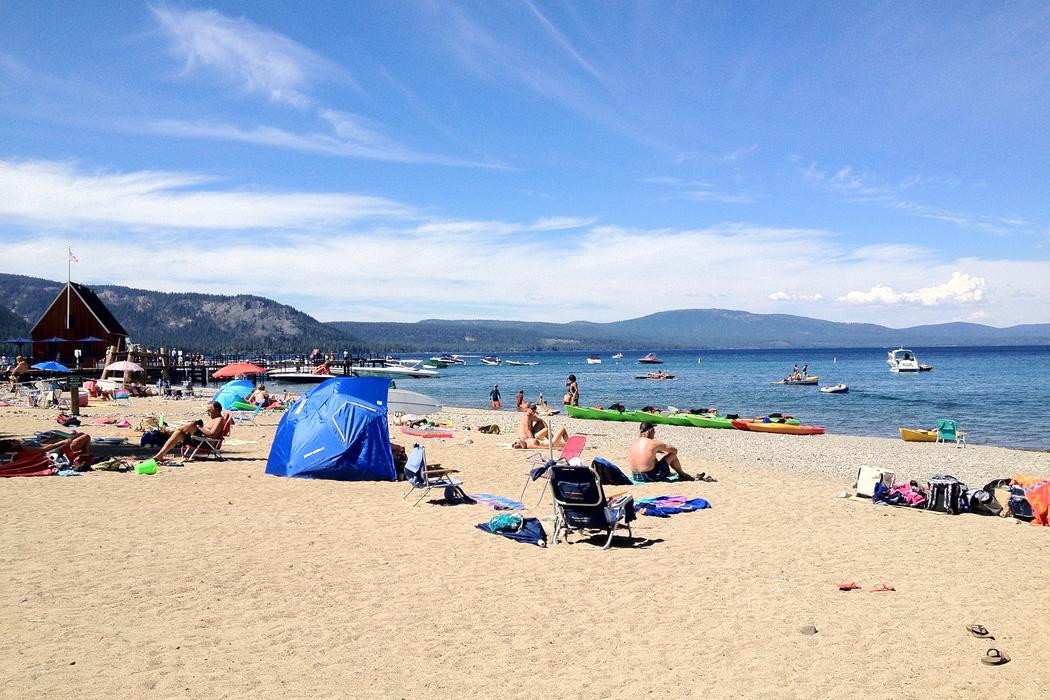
[{"xmin": 29, "ymin": 282, "xmax": 128, "ymax": 368}]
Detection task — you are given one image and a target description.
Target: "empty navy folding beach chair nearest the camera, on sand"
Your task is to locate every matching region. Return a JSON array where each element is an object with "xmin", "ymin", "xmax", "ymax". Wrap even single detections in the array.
[{"xmin": 549, "ymin": 464, "xmax": 635, "ymax": 549}]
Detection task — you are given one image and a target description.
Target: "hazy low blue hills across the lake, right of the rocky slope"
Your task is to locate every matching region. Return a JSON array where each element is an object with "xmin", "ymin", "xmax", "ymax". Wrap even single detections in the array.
[{"xmin": 329, "ymin": 309, "xmax": 1050, "ymax": 353}]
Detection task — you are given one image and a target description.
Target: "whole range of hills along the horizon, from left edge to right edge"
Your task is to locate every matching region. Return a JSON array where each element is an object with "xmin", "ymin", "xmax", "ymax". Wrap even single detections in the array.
[{"xmin": 0, "ymin": 273, "xmax": 1050, "ymax": 354}]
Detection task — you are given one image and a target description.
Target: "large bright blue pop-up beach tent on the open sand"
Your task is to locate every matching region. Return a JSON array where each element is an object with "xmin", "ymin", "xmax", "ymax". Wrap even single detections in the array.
[{"xmin": 266, "ymin": 377, "xmax": 397, "ymax": 481}]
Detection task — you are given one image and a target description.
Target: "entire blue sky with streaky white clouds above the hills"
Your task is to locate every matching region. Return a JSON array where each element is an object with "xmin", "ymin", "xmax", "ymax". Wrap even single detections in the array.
[{"xmin": 0, "ymin": 0, "xmax": 1050, "ymax": 326}]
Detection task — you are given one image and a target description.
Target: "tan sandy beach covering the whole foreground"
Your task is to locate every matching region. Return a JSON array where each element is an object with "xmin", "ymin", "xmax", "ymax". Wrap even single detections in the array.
[{"xmin": 0, "ymin": 399, "xmax": 1050, "ymax": 698}]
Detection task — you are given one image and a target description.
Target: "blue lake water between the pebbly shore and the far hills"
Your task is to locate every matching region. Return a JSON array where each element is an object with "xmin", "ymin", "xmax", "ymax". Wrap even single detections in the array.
[{"xmin": 266, "ymin": 346, "xmax": 1050, "ymax": 450}]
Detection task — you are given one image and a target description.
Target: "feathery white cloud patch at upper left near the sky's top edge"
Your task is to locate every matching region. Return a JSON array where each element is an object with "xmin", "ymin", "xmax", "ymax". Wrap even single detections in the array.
[{"xmin": 150, "ymin": 5, "xmax": 341, "ymax": 107}]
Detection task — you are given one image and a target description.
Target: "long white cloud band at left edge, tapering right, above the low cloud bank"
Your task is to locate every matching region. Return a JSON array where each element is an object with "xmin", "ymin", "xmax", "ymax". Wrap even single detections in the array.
[{"xmin": 0, "ymin": 161, "xmax": 414, "ymax": 230}]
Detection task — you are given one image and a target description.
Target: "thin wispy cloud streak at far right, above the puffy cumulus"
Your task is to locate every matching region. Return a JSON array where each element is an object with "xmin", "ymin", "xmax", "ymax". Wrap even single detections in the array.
[{"xmin": 802, "ymin": 164, "xmax": 1029, "ymax": 235}]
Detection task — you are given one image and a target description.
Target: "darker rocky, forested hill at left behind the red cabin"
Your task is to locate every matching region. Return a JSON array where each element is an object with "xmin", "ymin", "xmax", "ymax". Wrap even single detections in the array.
[{"xmin": 0, "ymin": 273, "xmax": 353, "ymax": 353}]
